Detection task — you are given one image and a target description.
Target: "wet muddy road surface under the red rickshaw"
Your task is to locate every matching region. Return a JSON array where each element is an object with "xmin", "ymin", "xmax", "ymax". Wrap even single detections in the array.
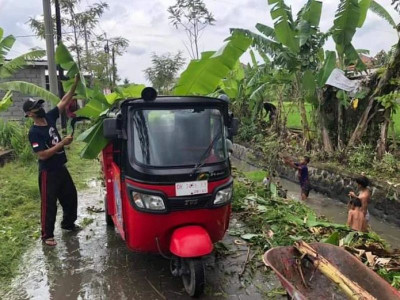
[{"xmin": 0, "ymin": 179, "xmax": 280, "ymax": 300}]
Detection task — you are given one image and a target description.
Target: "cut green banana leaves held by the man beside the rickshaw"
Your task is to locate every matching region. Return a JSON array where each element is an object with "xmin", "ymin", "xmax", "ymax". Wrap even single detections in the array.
[{"xmin": 56, "ymin": 43, "xmax": 144, "ymax": 159}]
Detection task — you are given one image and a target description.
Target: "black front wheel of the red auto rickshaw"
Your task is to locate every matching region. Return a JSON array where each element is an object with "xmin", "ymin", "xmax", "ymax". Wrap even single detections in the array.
[{"xmin": 182, "ymin": 258, "xmax": 205, "ymax": 297}]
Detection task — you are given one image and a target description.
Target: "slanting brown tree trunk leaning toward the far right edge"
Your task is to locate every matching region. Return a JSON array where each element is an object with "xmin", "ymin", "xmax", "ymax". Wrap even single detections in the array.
[{"xmin": 347, "ymin": 40, "xmax": 400, "ymax": 147}]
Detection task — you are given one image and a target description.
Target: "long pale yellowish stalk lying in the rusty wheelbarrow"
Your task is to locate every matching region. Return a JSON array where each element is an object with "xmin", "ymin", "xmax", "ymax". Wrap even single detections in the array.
[{"xmin": 294, "ymin": 241, "xmax": 376, "ymax": 300}]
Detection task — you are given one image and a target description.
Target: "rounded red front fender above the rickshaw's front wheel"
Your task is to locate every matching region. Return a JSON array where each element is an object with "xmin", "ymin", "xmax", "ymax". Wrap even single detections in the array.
[{"xmin": 169, "ymin": 225, "xmax": 213, "ymax": 257}]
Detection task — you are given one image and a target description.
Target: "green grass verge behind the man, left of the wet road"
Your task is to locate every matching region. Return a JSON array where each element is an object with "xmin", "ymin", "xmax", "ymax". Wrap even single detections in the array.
[{"xmin": 0, "ymin": 142, "xmax": 99, "ymax": 294}]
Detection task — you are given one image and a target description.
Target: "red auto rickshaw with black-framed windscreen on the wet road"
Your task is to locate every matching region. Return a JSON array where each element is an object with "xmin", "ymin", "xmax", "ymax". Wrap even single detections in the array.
[{"xmin": 102, "ymin": 88, "xmax": 238, "ymax": 296}]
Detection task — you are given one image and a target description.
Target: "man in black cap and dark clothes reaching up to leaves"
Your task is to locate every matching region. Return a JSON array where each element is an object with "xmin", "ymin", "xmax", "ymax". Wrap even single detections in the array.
[{"xmin": 23, "ymin": 76, "xmax": 79, "ymax": 246}]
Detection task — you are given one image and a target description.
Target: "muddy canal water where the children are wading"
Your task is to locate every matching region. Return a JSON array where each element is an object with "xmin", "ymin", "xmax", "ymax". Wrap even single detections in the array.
[{"xmin": 232, "ymin": 158, "xmax": 400, "ymax": 249}]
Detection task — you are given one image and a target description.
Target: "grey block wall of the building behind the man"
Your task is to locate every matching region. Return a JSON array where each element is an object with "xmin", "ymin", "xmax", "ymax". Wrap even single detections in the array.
[{"xmin": 0, "ymin": 65, "xmax": 49, "ymax": 120}]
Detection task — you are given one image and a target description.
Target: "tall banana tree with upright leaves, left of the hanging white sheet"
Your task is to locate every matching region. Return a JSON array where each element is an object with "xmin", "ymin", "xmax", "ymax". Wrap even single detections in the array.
[{"xmin": 231, "ymin": 0, "xmax": 326, "ymax": 149}]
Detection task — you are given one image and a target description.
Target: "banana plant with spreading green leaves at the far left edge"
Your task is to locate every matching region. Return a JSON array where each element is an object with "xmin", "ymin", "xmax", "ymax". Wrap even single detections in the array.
[{"xmin": 0, "ymin": 28, "xmax": 60, "ymax": 111}]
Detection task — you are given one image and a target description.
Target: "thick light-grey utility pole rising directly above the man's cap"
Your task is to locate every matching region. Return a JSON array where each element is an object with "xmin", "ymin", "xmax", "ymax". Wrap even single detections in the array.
[{"xmin": 43, "ymin": 0, "xmax": 58, "ymax": 102}]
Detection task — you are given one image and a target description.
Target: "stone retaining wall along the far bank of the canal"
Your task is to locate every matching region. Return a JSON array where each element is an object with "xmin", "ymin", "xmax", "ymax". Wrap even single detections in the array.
[{"xmin": 233, "ymin": 144, "xmax": 400, "ymax": 226}]
